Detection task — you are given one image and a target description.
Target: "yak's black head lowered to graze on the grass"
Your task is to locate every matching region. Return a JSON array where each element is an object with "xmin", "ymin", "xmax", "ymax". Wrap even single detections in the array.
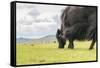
[{"xmin": 56, "ymin": 29, "xmax": 66, "ymax": 48}]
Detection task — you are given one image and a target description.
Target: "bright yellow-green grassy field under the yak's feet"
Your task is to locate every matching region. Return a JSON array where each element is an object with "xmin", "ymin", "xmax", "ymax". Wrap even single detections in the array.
[{"xmin": 16, "ymin": 41, "xmax": 96, "ymax": 65}]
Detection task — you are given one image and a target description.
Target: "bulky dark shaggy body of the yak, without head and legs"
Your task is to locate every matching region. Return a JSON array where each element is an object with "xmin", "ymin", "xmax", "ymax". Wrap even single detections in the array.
[{"xmin": 61, "ymin": 6, "xmax": 97, "ymax": 40}]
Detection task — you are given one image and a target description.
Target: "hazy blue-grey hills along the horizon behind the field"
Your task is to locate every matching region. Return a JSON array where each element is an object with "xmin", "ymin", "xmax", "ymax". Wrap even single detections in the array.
[{"xmin": 16, "ymin": 35, "xmax": 56, "ymax": 43}]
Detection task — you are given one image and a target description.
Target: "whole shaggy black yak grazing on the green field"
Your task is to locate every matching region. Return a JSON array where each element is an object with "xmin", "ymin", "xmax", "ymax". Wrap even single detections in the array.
[{"xmin": 56, "ymin": 6, "xmax": 97, "ymax": 49}]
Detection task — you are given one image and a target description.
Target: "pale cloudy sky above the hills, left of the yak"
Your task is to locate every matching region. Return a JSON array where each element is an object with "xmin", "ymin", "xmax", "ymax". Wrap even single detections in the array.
[{"xmin": 16, "ymin": 3, "xmax": 66, "ymax": 38}]
